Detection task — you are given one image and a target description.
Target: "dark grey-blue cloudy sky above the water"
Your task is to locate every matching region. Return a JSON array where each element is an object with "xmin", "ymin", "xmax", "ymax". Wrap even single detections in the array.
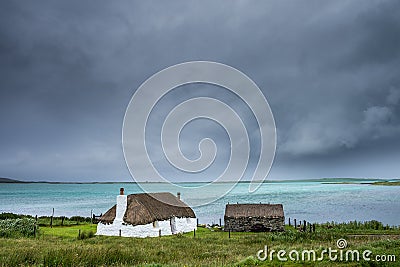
[{"xmin": 0, "ymin": 0, "xmax": 400, "ymax": 182}]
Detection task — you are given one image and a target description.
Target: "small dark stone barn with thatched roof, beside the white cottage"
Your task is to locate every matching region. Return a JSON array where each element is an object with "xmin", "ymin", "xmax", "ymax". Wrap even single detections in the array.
[{"xmin": 224, "ymin": 204, "xmax": 285, "ymax": 232}]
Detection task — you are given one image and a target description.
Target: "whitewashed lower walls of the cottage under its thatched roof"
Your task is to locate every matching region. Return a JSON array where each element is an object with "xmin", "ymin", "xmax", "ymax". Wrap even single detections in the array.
[{"xmin": 96, "ymin": 218, "xmax": 197, "ymax": 237}]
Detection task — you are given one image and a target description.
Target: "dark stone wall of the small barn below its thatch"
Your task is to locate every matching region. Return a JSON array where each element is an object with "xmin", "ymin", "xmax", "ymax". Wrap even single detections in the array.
[{"xmin": 224, "ymin": 217, "xmax": 285, "ymax": 232}]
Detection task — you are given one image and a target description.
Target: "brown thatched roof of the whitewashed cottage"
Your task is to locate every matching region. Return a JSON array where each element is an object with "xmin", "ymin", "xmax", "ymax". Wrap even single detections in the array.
[{"xmin": 100, "ymin": 193, "xmax": 196, "ymax": 225}]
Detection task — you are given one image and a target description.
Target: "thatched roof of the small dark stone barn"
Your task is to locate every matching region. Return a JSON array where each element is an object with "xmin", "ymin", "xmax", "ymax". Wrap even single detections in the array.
[{"xmin": 225, "ymin": 204, "xmax": 284, "ymax": 218}]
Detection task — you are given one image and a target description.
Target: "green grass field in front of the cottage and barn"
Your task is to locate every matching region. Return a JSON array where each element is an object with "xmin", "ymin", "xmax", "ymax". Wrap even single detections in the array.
[{"xmin": 0, "ymin": 222, "xmax": 400, "ymax": 266}]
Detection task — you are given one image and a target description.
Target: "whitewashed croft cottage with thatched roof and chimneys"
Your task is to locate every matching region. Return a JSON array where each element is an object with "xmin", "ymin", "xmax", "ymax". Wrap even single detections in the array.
[{"xmin": 96, "ymin": 188, "xmax": 197, "ymax": 237}]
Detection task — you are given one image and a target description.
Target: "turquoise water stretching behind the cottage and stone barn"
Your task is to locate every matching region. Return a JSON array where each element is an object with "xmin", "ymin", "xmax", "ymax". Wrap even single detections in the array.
[{"xmin": 0, "ymin": 182, "xmax": 400, "ymax": 225}]
